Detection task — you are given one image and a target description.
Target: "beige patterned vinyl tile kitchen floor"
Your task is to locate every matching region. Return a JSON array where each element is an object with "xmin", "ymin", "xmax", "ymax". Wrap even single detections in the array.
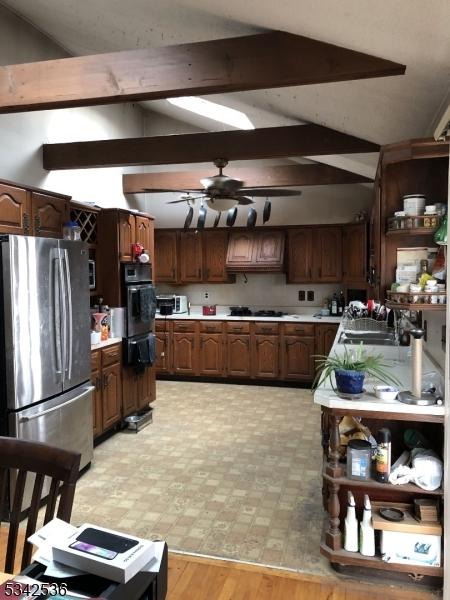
[{"xmin": 72, "ymin": 381, "xmax": 333, "ymax": 575}]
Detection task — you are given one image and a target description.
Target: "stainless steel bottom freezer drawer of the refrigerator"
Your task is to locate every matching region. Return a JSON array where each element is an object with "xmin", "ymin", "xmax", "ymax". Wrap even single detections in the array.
[{"xmin": 10, "ymin": 384, "xmax": 94, "ymax": 469}]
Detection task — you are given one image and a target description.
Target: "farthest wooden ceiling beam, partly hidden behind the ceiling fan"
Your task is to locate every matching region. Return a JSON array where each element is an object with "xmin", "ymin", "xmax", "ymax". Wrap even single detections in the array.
[{"xmin": 122, "ymin": 164, "xmax": 373, "ymax": 194}]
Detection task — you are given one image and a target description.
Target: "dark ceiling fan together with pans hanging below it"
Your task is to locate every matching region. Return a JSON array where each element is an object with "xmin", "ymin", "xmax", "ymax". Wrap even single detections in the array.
[{"xmin": 161, "ymin": 158, "xmax": 301, "ymax": 229}]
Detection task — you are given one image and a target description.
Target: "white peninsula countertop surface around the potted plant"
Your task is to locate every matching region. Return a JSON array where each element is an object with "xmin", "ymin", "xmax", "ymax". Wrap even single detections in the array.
[{"xmin": 314, "ymin": 325, "xmax": 445, "ymax": 416}]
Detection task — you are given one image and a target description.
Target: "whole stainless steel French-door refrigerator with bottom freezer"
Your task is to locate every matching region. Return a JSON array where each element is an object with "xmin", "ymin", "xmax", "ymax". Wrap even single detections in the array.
[{"xmin": 0, "ymin": 235, "xmax": 93, "ymax": 482}]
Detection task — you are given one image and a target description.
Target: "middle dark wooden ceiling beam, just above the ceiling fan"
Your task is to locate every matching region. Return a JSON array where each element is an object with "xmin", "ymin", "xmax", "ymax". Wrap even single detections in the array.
[{"xmin": 43, "ymin": 125, "xmax": 380, "ymax": 171}]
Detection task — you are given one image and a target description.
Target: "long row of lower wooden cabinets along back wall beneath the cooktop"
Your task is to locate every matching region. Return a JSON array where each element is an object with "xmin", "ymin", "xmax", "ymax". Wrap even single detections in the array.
[{"xmin": 154, "ymin": 319, "xmax": 338, "ymax": 384}]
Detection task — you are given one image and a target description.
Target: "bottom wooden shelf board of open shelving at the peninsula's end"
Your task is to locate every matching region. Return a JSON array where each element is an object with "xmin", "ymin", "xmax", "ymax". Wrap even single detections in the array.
[{"xmin": 320, "ymin": 540, "xmax": 444, "ymax": 577}]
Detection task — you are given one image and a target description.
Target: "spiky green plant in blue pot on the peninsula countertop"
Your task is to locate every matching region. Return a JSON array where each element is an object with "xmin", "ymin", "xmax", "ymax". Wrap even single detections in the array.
[{"xmin": 312, "ymin": 344, "xmax": 401, "ymax": 395}]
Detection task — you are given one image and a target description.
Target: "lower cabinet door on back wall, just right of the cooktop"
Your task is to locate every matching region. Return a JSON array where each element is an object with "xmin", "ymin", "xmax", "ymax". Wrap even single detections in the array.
[{"xmin": 281, "ymin": 335, "xmax": 314, "ymax": 381}]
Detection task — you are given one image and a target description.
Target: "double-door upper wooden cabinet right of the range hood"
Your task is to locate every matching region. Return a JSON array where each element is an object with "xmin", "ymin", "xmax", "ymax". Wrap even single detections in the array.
[{"xmin": 287, "ymin": 226, "xmax": 342, "ymax": 283}]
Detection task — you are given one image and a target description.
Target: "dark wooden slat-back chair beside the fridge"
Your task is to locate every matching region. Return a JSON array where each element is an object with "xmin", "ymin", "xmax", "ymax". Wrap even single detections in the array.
[{"xmin": 0, "ymin": 437, "xmax": 81, "ymax": 573}]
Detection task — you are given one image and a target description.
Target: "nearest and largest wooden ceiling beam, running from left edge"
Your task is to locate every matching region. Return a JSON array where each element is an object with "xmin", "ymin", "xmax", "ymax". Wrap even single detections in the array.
[{"xmin": 0, "ymin": 31, "xmax": 406, "ymax": 113}]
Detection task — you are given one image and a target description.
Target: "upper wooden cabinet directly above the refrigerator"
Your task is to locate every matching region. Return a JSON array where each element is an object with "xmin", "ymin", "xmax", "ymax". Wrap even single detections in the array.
[{"xmin": 0, "ymin": 182, "xmax": 70, "ymax": 238}]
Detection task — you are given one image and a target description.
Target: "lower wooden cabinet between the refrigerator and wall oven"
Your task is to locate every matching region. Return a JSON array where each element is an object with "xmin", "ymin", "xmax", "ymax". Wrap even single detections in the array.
[{"xmin": 91, "ymin": 344, "xmax": 122, "ymax": 438}]
